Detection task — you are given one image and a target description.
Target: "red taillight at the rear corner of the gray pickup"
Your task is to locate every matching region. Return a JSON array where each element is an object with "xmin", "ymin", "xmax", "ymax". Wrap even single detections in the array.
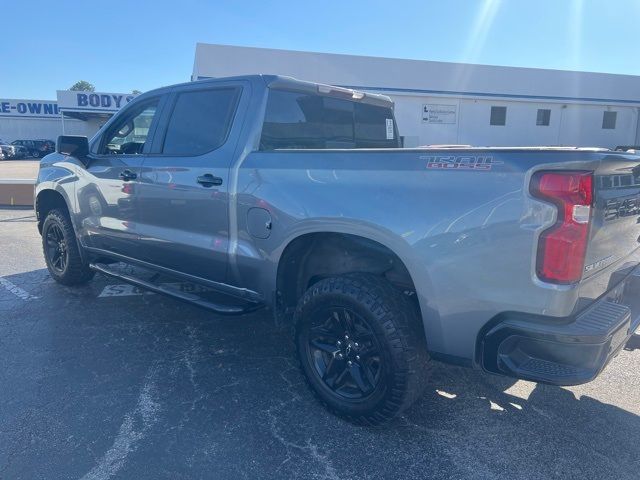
[{"xmin": 531, "ymin": 171, "xmax": 593, "ymax": 284}]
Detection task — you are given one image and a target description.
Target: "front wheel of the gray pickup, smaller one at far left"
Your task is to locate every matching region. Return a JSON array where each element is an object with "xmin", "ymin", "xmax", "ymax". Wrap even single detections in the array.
[{"xmin": 42, "ymin": 209, "xmax": 94, "ymax": 285}]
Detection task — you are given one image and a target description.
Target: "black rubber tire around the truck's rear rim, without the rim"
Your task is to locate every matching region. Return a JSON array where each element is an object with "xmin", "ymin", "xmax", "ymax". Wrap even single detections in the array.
[{"xmin": 294, "ymin": 274, "xmax": 429, "ymax": 426}]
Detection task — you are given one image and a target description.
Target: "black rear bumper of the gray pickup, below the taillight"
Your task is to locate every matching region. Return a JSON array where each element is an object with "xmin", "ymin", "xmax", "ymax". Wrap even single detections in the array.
[{"xmin": 479, "ymin": 267, "xmax": 640, "ymax": 385}]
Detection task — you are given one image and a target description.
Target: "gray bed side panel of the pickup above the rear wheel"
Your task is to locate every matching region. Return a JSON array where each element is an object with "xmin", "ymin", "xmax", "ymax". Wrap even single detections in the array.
[{"xmin": 231, "ymin": 150, "xmax": 616, "ymax": 358}]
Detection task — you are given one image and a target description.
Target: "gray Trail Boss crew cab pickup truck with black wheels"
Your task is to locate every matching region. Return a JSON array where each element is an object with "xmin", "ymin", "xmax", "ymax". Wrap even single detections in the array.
[{"xmin": 35, "ymin": 75, "xmax": 640, "ymax": 424}]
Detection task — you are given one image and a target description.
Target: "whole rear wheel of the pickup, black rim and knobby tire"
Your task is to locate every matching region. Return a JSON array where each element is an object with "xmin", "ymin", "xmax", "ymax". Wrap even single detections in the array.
[{"xmin": 295, "ymin": 274, "xmax": 428, "ymax": 425}]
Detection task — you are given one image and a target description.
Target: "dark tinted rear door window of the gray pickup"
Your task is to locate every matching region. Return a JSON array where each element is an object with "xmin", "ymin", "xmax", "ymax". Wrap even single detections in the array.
[{"xmin": 162, "ymin": 87, "xmax": 240, "ymax": 156}]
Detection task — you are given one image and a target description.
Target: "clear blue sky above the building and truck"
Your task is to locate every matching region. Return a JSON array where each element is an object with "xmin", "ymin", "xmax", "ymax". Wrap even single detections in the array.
[{"xmin": 0, "ymin": 0, "xmax": 640, "ymax": 100}]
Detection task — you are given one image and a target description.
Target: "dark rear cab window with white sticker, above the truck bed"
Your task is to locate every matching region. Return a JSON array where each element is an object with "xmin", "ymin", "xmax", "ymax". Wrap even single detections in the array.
[{"xmin": 260, "ymin": 89, "xmax": 400, "ymax": 151}]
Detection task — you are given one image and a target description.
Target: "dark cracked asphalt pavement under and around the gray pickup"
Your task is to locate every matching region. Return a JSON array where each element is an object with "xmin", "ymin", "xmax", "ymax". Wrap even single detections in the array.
[{"xmin": 0, "ymin": 209, "xmax": 640, "ymax": 480}]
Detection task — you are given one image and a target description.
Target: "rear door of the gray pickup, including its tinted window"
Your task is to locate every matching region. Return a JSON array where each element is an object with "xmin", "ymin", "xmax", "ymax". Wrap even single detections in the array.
[{"xmin": 138, "ymin": 82, "xmax": 247, "ymax": 281}]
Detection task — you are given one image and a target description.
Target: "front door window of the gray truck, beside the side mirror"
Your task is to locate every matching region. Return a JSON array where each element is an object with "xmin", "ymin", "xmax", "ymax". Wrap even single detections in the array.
[{"xmin": 98, "ymin": 99, "xmax": 159, "ymax": 155}]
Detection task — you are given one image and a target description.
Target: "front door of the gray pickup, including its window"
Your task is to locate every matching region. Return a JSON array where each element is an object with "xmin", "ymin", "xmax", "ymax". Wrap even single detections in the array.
[{"xmin": 76, "ymin": 96, "xmax": 164, "ymax": 258}]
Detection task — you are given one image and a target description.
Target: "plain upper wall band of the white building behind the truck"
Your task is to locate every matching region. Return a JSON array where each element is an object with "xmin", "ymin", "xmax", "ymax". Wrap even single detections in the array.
[{"xmin": 192, "ymin": 43, "xmax": 640, "ymax": 105}]
